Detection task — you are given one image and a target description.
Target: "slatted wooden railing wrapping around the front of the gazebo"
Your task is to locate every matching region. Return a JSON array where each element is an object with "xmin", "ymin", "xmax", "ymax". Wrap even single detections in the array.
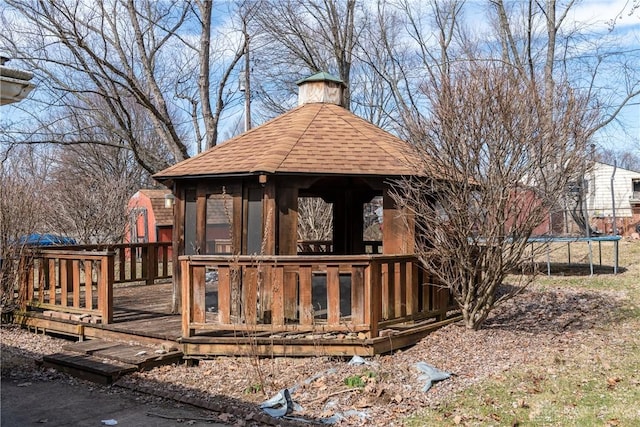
[{"xmin": 180, "ymin": 255, "xmax": 451, "ymax": 337}]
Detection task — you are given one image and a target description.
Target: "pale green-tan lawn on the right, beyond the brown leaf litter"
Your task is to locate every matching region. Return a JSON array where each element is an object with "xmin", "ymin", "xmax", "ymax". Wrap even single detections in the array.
[{"xmin": 407, "ymin": 241, "xmax": 640, "ymax": 426}]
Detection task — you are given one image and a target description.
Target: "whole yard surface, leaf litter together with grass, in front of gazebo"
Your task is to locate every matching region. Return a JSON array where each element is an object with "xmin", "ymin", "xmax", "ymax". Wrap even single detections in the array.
[{"xmin": 5, "ymin": 241, "xmax": 640, "ymax": 427}]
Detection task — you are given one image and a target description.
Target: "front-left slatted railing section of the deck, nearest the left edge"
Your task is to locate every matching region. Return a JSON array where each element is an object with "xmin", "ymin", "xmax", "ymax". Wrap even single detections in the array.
[{"xmin": 20, "ymin": 250, "xmax": 114, "ymax": 324}]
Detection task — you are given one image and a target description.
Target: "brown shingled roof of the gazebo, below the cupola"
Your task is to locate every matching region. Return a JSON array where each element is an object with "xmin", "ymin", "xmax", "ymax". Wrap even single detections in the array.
[{"xmin": 154, "ymin": 102, "xmax": 419, "ymax": 181}]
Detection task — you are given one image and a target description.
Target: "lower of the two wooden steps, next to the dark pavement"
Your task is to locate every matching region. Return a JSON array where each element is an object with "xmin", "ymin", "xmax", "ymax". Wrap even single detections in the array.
[{"xmin": 42, "ymin": 352, "xmax": 138, "ymax": 384}]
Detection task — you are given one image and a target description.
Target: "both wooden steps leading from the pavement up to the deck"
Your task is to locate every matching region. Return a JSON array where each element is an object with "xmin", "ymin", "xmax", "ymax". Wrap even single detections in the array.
[{"xmin": 42, "ymin": 339, "xmax": 183, "ymax": 384}]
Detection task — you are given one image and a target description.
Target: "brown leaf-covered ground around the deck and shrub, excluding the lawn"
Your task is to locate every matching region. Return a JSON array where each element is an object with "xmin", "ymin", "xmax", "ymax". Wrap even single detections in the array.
[{"xmin": 2, "ymin": 272, "xmax": 625, "ymax": 426}]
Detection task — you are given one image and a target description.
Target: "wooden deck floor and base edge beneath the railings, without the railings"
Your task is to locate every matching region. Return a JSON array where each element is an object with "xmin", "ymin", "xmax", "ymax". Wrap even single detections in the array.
[{"xmin": 17, "ymin": 283, "xmax": 459, "ymax": 358}]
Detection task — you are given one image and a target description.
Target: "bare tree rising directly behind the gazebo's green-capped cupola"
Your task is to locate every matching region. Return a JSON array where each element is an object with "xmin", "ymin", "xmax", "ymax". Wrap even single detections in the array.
[{"xmin": 254, "ymin": 0, "xmax": 358, "ymax": 113}]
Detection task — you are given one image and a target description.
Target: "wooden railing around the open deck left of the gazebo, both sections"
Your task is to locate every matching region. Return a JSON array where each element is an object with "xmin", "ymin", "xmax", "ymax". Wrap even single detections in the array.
[{"xmin": 19, "ymin": 242, "xmax": 171, "ymax": 324}]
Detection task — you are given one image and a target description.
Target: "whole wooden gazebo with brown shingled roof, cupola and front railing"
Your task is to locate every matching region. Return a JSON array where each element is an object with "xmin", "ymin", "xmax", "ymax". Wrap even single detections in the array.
[{"xmin": 154, "ymin": 73, "xmax": 460, "ymax": 354}]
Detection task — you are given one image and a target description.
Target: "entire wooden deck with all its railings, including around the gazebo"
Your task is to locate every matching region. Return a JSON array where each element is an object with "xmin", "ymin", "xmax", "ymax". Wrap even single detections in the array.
[{"xmin": 16, "ymin": 247, "xmax": 459, "ymax": 358}]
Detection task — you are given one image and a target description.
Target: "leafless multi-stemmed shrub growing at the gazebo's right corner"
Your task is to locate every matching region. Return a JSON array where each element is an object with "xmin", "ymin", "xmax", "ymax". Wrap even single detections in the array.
[{"xmin": 396, "ymin": 61, "xmax": 597, "ymax": 329}]
